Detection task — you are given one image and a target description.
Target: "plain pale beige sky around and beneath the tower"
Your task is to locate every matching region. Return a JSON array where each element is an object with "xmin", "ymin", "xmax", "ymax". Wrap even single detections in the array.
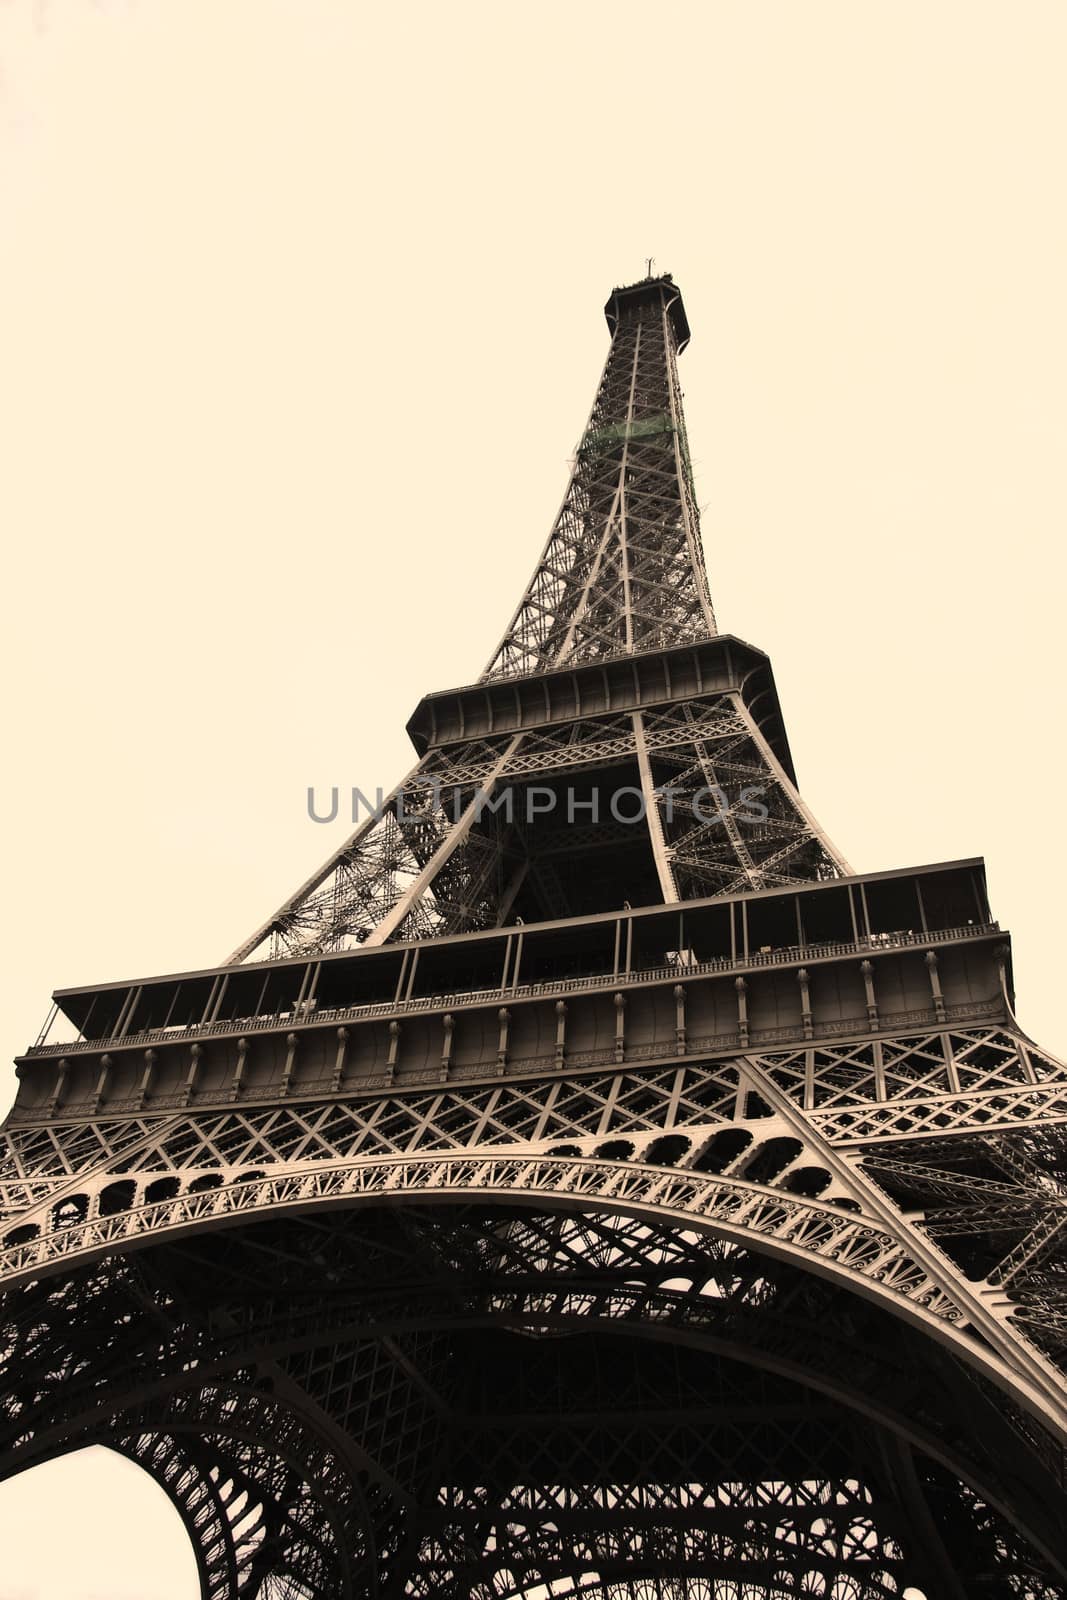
[{"xmin": 0, "ymin": 0, "xmax": 1067, "ymax": 1600}]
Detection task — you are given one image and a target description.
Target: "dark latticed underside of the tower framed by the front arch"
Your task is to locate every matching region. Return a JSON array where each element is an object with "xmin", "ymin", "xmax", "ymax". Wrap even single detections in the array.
[{"xmin": 4, "ymin": 1195, "xmax": 1056, "ymax": 1600}]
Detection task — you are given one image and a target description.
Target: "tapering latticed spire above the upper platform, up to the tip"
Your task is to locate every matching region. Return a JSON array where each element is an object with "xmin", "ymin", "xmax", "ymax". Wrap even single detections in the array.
[{"xmin": 483, "ymin": 272, "xmax": 717, "ymax": 680}]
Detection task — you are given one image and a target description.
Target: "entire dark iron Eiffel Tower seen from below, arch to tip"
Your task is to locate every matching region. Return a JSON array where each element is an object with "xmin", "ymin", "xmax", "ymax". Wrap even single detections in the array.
[{"xmin": 0, "ymin": 275, "xmax": 1067, "ymax": 1600}]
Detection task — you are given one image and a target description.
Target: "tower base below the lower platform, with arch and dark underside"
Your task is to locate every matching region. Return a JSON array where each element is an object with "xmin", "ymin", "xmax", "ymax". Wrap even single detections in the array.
[{"xmin": 0, "ymin": 1029, "xmax": 1067, "ymax": 1600}]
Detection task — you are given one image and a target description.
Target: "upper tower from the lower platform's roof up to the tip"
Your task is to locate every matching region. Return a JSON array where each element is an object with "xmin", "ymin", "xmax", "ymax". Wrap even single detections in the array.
[{"xmin": 223, "ymin": 274, "xmax": 848, "ymax": 962}]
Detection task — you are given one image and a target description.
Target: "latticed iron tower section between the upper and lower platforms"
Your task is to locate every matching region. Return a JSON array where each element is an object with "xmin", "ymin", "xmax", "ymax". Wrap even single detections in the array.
[{"xmin": 235, "ymin": 693, "xmax": 846, "ymax": 960}]
